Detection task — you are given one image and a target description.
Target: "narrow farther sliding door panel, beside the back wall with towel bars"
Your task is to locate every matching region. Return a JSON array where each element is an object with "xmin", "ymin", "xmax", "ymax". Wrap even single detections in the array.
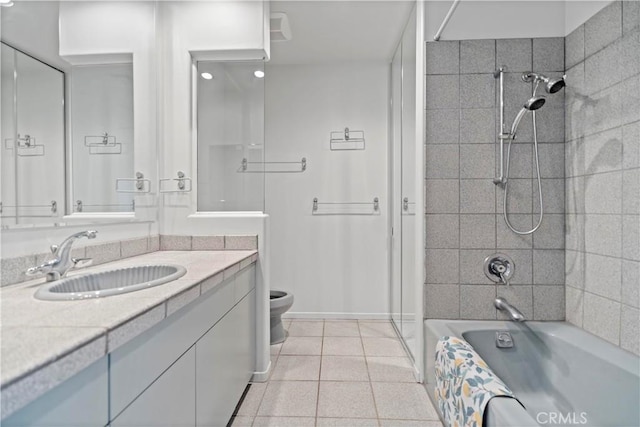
[{"xmin": 389, "ymin": 44, "xmax": 402, "ymax": 331}]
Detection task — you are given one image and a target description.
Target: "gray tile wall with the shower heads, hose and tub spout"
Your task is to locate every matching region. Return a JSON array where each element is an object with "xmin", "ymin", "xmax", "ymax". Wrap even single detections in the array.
[{"xmin": 425, "ymin": 38, "xmax": 565, "ymax": 320}]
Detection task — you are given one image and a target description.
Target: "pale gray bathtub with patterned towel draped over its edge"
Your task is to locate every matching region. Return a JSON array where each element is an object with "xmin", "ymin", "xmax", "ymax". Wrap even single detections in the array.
[{"xmin": 425, "ymin": 319, "xmax": 640, "ymax": 427}]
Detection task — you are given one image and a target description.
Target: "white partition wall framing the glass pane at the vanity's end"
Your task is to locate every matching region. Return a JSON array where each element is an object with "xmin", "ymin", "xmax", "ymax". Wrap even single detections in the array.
[{"xmin": 157, "ymin": 1, "xmax": 270, "ymax": 379}]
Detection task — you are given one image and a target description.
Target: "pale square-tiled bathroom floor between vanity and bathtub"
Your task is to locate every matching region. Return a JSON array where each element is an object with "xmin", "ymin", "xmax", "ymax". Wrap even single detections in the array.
[{"xmin": 231, "ymin": 320, "xmax": 442, "ymax": 427}]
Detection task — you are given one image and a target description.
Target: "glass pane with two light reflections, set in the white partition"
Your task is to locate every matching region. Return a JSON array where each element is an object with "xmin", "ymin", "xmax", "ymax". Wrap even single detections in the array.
[{"xmin": 197, "ymin": 61, "xmax": 264, "ymax": 212}]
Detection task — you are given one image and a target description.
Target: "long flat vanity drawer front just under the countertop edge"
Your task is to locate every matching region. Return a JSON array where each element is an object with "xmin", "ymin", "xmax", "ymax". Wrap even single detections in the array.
[{"xmin": 109, "ymin": 277, "xmax": 234, "ymax": 417}]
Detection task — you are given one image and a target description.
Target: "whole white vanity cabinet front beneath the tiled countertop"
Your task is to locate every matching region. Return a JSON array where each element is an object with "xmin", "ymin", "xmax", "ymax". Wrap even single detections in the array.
[{"xmin": 1, "ymin": 264, "xmax": 256, "ymax": 427}]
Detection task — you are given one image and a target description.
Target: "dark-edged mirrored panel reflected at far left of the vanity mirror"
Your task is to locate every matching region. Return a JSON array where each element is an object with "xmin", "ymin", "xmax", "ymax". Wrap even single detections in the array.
[{"xmin": 0, "ymin": 43, "xmax": 65, "ymax": 227}]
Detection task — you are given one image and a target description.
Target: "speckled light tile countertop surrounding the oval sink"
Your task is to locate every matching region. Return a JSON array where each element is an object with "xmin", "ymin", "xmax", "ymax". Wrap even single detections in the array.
[{"xmin": 0, "ymin": 250, "xmax": 257, "ymax": 416}]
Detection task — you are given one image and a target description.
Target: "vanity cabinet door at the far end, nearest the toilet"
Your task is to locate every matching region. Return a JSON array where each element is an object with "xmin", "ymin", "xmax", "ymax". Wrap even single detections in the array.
[{"xmin": 196, "ymin": 291, "xmax": 255, "ymax": 427}]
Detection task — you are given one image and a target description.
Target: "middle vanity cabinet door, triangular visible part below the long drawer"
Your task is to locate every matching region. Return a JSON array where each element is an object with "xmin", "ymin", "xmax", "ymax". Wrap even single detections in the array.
[{"xmin": 111, "ymin": 347, "xmax": 196, "ymax": 427}]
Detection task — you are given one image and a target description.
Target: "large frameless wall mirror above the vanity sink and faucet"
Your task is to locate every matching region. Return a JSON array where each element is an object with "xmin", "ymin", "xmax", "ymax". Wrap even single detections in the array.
[{"xmin": 1, "ymin": 1, "xmax": 157, "ymax": 228}]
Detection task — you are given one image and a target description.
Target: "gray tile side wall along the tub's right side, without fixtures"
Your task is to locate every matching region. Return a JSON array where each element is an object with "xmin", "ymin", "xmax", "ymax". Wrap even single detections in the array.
[{"xmin": 565, "ymin": 1, "xmax": 640, "ymax": 354}]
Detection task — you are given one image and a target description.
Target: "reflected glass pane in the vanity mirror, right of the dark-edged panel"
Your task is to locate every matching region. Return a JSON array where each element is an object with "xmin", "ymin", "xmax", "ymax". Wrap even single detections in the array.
[{"xmin": 69, "ymin": 63, "xmax": 135, "ymax": 212}]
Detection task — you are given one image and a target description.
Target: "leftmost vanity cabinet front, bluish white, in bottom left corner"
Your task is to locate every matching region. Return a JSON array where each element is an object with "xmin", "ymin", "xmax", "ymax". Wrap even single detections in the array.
[{"xmin": 0, "ymin": 357, "xmax": 109, "ymax": 427}]
